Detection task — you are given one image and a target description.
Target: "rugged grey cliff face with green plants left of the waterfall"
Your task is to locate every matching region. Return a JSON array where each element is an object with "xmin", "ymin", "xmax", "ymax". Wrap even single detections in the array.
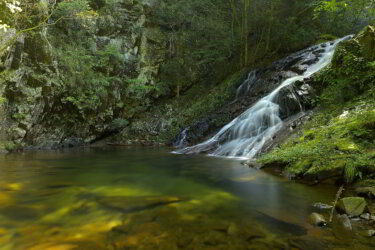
[{"xmin": 0, "ymin": 0, "xmax": 238, "ymax": 150}]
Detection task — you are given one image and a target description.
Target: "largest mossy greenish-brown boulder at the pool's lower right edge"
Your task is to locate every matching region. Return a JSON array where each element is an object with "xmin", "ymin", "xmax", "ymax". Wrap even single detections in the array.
[{"xmin": 336, "ymin": 197, "xmax": 368, "ymax": 217}]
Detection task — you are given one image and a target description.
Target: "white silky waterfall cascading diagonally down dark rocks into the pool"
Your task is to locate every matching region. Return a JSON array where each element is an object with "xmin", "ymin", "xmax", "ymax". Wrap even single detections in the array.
[{"xmin": 175, "ymin": 37, "xmax": 348, "ymax": 159}]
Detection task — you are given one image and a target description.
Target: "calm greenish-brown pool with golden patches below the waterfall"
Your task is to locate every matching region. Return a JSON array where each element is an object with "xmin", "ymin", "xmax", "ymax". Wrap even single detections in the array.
[{"xmin": 0, "ymin": 147, "xmax": 375, "ymax": 250}]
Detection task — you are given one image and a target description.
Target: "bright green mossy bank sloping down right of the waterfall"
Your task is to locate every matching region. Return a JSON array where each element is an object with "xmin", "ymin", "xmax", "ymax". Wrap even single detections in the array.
[{"xmin": 258, "ymin": 26, "xmax": 375, "ymax": 182}]
